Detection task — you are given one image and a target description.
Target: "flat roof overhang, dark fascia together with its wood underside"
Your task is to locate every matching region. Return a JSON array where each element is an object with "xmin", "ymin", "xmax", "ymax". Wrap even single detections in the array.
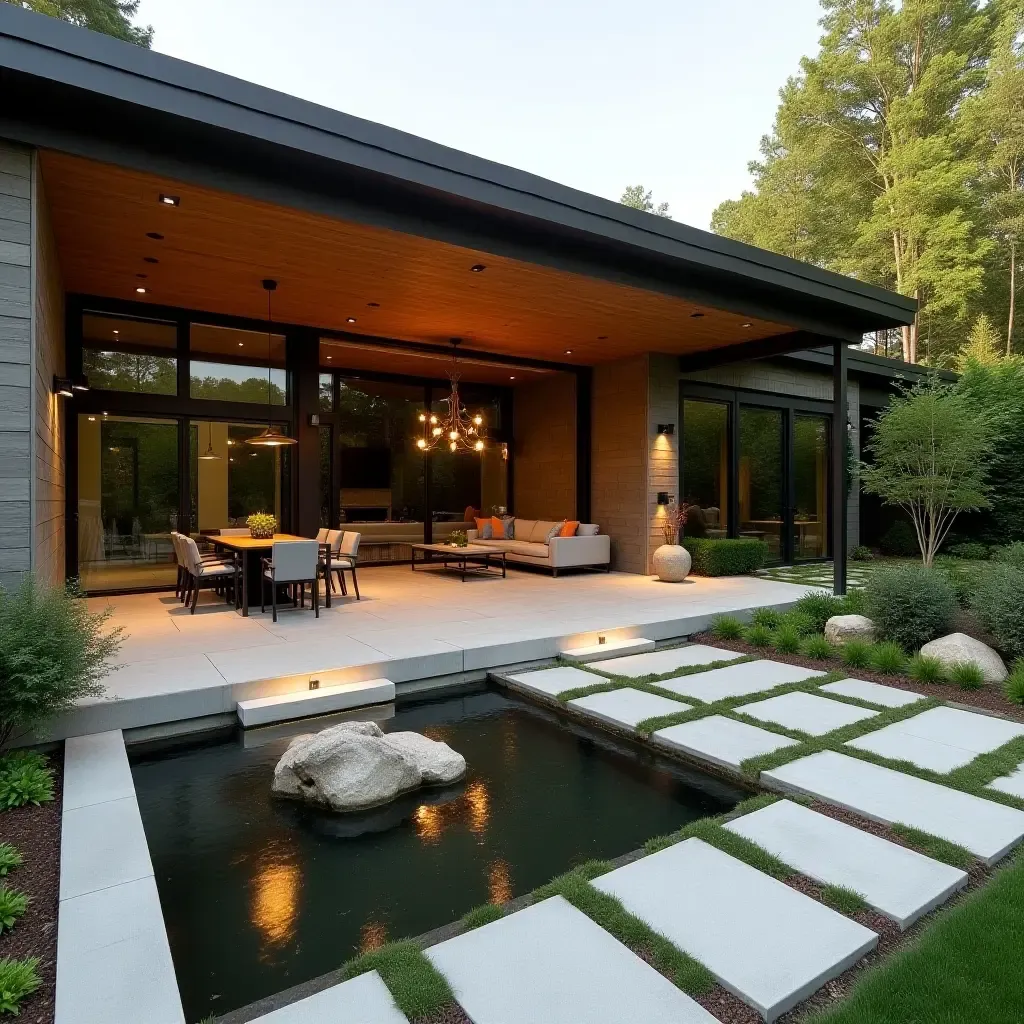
[{"xmin": 0, "ymin": 4, "xmax": 914, "ymax": 362}]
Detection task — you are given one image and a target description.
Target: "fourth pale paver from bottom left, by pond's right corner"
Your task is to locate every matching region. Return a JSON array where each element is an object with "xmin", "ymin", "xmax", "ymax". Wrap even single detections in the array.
[{"xmin": 725, "ymin": 800, "xmax": 968, "ymax": 928}]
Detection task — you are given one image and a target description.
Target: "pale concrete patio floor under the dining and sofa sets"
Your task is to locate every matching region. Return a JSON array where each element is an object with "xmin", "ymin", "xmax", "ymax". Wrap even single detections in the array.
[{"xmin": 52, "ymin": 566, "xmax": 808, "ymax": 738}]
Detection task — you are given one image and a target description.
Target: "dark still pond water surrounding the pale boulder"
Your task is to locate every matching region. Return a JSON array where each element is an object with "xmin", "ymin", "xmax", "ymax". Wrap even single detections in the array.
[{"xmin": 132, "ymin": 690, "xmax": 742, "ymax": 1022}]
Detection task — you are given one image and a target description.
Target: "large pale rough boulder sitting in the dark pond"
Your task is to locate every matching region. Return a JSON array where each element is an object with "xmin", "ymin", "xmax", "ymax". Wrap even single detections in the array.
[{"xmin": 271, "ymin": 722, "xmax": 466, "ymax": 811}]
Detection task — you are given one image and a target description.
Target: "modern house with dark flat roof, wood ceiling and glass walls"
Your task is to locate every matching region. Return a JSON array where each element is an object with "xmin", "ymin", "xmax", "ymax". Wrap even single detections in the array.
[{"xmin": 0, "ymin": 4, "xmax": 914, "ymax": 592}]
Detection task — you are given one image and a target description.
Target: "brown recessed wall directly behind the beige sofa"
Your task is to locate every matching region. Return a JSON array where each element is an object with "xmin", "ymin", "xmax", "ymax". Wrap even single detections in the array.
[{"xmin": 512, "ymin": 373, "xmax": 577, "ymax": 519}]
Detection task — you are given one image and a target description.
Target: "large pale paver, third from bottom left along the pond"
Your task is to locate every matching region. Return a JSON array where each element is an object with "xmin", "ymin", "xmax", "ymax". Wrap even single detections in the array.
[{"xmin": 593, "ymin": 839, "xmax": 879, "ymax": 1021}]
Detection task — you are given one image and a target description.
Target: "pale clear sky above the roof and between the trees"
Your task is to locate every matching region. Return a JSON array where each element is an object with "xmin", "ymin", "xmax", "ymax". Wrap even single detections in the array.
[{"xmin": 137, "ymin": 0, "xmax": 820, "ymax": 227}]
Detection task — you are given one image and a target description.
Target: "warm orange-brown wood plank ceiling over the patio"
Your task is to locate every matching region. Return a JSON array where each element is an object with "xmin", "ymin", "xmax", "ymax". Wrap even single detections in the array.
[{"xmin": 42, "ymin": 152, "xmax": 790, "ymax": 365}]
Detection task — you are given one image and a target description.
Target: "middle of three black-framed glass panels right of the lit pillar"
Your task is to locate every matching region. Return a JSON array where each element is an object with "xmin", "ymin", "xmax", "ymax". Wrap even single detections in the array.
[{"xmin": 738, "ymin": 406, "xmax": 785, "ymax": 562}]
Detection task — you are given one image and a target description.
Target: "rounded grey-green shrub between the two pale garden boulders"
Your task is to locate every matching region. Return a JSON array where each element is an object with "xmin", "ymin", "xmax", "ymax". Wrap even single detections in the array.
[{"xmin": 864, "ymin": 565, "xmax": 956, "ymax": 650}]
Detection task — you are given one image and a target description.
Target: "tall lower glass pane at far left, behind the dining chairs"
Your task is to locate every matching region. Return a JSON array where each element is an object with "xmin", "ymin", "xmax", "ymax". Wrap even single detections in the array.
[{"xmin": 78, "ymin": 414, "xmax": 179, "ymax": 592}]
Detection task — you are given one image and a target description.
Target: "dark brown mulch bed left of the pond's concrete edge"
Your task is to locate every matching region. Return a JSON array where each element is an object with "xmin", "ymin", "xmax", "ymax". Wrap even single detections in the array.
[{"xmin": 0, "ymin": 748, "xmax": 63, "ymax": 1024}]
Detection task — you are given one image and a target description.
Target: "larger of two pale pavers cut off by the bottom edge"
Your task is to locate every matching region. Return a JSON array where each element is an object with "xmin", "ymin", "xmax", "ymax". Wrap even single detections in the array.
[{"xmin": 426, "ymin": 896, "xmax": 715, "ymax": 1024}]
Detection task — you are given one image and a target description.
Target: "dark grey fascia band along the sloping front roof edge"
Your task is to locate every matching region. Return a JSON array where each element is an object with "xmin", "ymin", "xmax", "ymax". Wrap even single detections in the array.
[{"xmin": 0, "ymin": 4, "xmax": 915, "ymax": 335}]
